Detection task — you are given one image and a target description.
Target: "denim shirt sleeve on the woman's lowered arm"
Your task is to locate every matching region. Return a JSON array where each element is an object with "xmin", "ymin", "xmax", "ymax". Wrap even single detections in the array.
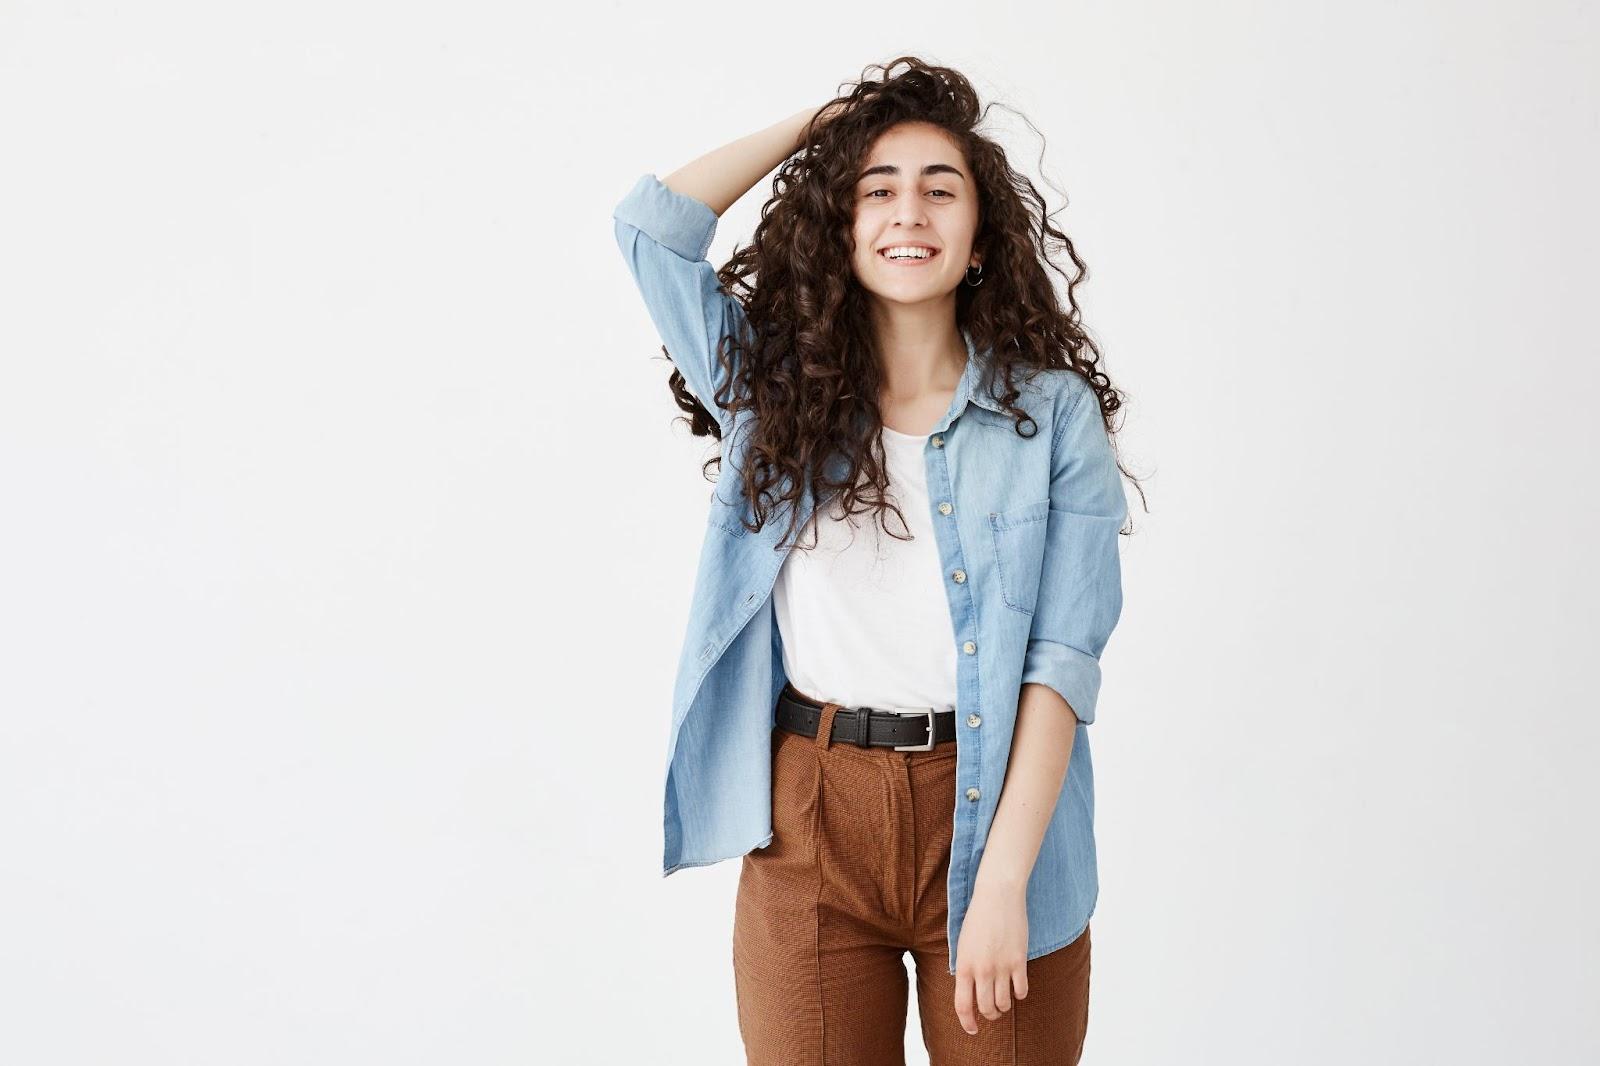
[{"xmin": 1022, "ymin": 375, "xmax": 1128, "ymax": 725}]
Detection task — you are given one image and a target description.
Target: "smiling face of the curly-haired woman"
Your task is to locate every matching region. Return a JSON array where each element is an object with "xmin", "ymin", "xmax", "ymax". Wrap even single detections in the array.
[{"xmin": 851, "ymin": 122, "xmax": 981, "ymax": 304}]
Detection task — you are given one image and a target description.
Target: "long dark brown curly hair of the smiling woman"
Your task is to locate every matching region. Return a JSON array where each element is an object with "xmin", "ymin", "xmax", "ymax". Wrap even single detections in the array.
[{"xmin": 662, "ymin": 56, "xmax": 1142, "ymax": 547}]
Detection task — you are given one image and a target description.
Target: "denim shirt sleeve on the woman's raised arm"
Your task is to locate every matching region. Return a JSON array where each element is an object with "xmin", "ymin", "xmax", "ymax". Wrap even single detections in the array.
[{"xmin": 611, "ymin": 173, "xmax": 744, "ymax": 432}]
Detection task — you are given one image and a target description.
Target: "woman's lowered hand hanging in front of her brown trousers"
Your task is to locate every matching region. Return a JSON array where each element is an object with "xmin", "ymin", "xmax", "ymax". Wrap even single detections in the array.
[{"xmin": 955, "ymin": 879, "xmax": 1027, "ymax": 1032}]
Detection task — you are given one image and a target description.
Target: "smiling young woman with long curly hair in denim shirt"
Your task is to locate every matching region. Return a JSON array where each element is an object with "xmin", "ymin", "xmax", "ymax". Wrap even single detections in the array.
[{"xmin": 614, "ymin": 58, "xmax": 1128, "ymax": 1066}]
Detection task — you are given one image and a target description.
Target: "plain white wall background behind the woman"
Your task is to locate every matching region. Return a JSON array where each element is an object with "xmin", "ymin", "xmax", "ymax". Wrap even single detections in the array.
[{"xmin": 0, "ymin": 2, "xmax": 1600, "ymax": 1066}]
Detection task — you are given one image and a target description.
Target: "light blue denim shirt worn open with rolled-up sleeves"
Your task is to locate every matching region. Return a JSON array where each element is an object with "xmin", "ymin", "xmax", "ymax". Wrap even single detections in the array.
[{"xmin": 613, "ymin": 173, "xmax": 1128, "ymax": 973}]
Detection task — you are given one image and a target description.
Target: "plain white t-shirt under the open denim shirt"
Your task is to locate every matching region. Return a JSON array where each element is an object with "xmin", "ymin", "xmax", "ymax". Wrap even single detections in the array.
[{"xmin": 773, "ymin": 426, "xmax": 957, "ymax": 711}]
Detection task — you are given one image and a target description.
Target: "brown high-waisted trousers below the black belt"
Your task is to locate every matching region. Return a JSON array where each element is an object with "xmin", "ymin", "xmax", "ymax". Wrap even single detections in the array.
[{"xmin": 733, "ymin": 685, "xmax": 1090, "ymax": 1066}]
